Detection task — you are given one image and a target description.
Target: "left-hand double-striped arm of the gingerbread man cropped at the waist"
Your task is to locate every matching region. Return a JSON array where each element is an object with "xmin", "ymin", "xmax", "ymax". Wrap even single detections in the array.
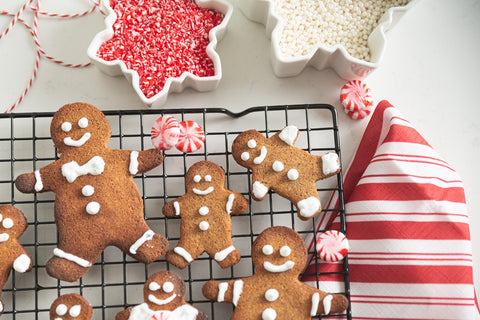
[{"xmin": 202, "ymin": 279, "xmax": 244, "ymax": 306}]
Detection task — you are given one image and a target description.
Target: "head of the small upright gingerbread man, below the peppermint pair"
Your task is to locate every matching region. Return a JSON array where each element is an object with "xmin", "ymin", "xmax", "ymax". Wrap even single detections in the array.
[{"xmin": 185, "ymin": 161, "xmax": 225, "ymax": 196}]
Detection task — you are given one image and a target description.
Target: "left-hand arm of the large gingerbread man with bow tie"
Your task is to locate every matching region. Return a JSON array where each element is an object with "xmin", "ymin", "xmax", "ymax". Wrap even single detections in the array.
[{"xmin": 15, "ymin": 161, "xmax": 61, "ymax": 193}]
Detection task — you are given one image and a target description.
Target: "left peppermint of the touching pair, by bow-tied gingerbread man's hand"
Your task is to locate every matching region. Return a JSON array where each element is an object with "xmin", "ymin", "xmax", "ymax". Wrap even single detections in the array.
[{"xmin": 152, "ymin": 116, "xmax": 180, "ymax": 150}]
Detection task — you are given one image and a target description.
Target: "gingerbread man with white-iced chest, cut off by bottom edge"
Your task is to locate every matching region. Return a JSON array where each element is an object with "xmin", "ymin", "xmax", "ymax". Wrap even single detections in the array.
[{"xmin": 115, "ymin": 271, "xmax": 208, "ymax": 320}]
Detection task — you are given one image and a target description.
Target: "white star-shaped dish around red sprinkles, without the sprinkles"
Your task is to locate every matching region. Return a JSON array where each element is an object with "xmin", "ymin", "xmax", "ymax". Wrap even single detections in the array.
[{"xmin": 87, "ymin": 0, "xmax": 233, "ymax": 108}]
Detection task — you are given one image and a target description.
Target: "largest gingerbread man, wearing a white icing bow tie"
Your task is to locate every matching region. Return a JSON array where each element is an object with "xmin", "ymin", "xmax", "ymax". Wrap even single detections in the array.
[{"xmin": 15, "ymin": 103, "xmax": 168, "ymax": 282}]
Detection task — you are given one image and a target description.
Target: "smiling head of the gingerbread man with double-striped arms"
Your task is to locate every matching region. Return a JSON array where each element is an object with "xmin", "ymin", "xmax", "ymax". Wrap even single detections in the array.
[{"xmin": 252, "ymin": 227, "xmax": 308, "ymax": 278}]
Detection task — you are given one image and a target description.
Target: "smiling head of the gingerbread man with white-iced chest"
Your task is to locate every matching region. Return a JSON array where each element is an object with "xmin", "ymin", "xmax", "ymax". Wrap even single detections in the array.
[{"xmin": 143, "ymin": 271, "xmax": 185, "ymax": 311}]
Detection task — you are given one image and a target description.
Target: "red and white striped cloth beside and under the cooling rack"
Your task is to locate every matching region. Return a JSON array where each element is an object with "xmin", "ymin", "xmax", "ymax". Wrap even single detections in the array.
[{"xmin": 302, "ymin": 101, "xmax": 480, "ymax": 320}]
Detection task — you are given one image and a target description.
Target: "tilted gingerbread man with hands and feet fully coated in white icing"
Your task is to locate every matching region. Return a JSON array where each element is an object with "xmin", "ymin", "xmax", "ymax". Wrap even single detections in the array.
[{"xmin": 232, "ymin": 126, "xmax": 340, "ymax": 220}]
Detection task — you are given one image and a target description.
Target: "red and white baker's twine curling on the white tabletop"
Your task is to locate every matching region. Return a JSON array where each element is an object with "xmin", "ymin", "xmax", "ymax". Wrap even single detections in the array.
[{"xmin": 0, "ymin": 0, "xmax": 105, "ymax": 113}]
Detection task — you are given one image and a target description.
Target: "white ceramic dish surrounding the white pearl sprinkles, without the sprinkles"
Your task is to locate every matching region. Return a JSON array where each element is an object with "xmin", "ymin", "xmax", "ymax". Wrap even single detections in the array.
[{"xmin": 239, "ymin": 0, "xmax": 420, "ymax": 80}]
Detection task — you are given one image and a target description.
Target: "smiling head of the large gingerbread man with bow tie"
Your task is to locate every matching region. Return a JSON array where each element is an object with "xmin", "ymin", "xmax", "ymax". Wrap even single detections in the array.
[{"xmin": 50, "ymin": 103, "xmax": 112, "ymax": 153}]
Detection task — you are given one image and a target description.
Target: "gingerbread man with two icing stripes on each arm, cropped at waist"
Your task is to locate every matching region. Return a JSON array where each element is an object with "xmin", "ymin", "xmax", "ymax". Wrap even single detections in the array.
[{"xmin": 203, "ymin": 227, "xmax": 348, "ymax": 320}]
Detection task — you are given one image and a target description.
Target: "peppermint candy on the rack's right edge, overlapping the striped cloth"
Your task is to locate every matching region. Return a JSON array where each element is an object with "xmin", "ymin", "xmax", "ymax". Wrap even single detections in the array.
[{"xmin": 317, "ymin": 230, "xmax": 350, "ymax": 262}]
